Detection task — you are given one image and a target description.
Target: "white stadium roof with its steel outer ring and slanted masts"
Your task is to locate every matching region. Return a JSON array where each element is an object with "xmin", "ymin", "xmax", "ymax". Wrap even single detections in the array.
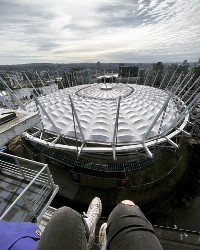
[{"xmin": 25, "ymin": 79, "xmax": 199, "ymax": 159}]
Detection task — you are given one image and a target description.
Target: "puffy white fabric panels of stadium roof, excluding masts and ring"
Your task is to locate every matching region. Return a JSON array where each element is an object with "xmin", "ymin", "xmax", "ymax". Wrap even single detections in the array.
[{"xmin": 27, "ymin": 83, "xmax": 178, "ymax": 144}]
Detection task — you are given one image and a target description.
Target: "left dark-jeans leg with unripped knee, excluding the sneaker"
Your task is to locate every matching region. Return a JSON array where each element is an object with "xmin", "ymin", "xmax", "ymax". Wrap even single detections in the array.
[{"xmin": 37, "ymin": 207, "xmax": 88, "ymax": 250}]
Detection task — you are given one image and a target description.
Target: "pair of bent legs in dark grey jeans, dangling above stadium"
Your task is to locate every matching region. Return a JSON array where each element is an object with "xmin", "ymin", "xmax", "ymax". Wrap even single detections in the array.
[{"xmin": 37, "ymin": 198, "xmax": 162, "ymax": 250}]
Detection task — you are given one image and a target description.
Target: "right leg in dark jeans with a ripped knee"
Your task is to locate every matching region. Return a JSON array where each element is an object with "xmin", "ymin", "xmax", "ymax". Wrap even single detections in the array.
[{"xmin": 106, "ymin": 200, "xmax": 162, "ymax": 250}]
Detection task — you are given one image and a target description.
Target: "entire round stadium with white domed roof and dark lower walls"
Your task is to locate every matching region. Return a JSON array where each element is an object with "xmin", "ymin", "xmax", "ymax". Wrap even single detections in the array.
[{"xmin": 14, "ymin": 69, "xmax": 199, "ymax": 206}]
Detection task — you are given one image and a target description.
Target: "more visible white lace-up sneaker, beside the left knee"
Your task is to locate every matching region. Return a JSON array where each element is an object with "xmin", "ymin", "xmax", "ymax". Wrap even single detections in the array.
[{"xmin": 84, "ymin": 197, "xmax": 102, "ymax": 249}]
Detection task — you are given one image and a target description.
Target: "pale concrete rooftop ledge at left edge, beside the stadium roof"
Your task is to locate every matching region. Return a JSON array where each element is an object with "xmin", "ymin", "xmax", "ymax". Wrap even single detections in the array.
[{"xmin": 0, "ymin": 108, "xmax": 40, "ymax": 146}]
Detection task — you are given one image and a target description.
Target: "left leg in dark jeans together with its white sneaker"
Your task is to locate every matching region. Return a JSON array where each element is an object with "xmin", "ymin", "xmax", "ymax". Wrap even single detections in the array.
[{"xmin": 37, "ymin": 197, "xmax": 102, "ymax": 250}]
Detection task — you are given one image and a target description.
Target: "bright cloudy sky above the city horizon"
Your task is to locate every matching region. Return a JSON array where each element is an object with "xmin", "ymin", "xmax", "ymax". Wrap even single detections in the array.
[{"xmin": 0, "ymin": 0, "xmax": 200, "ymax": 64}]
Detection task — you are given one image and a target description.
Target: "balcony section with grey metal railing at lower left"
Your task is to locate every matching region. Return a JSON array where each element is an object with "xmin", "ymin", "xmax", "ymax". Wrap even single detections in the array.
[{"xmin": 0, "ymin": 152, "xmax": 58, "ymax": 221}]
